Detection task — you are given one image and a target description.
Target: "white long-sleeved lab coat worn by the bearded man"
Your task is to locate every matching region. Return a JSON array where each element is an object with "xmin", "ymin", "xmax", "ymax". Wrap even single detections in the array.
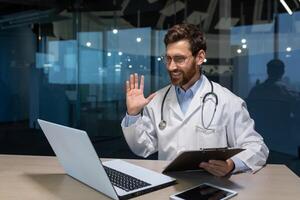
[{"xmin": 122, "ymin": 75, "xmax": 269, "ymax": 171}]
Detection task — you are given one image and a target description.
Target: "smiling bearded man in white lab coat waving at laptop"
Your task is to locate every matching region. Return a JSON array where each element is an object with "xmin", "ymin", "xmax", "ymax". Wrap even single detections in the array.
[{"xmin": 122, "ymin": 24, "xmax": 269, "ymax": 176}]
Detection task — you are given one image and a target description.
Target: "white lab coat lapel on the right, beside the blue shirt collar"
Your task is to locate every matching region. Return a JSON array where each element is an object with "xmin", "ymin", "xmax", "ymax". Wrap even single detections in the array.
[{"xmin": 185, "ymin": 75, "xmax": 211, "ymax": 119}]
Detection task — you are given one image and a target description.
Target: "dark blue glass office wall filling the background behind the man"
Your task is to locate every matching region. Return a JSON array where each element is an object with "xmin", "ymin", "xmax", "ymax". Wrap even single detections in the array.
[{"xmin": 0, "ymin": 0, "xmax": 300, "ymax": 174}]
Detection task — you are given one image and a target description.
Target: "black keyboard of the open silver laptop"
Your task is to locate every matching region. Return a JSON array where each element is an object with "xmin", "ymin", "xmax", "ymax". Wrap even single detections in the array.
[{"xmin": 104, "ymin": 166, "xmax": 150, "ymax": 192}]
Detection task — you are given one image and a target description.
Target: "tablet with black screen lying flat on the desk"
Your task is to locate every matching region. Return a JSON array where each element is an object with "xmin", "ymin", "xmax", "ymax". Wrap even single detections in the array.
[{"xmin": 170, "ymin": 183, "xmax": 237, "ymax": 200}]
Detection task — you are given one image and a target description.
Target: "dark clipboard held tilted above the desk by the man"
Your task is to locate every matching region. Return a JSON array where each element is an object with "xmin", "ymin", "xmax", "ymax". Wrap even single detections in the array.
[{"xmin": 162, "ymin": 148, "xmax": 245, "ymax": 173}]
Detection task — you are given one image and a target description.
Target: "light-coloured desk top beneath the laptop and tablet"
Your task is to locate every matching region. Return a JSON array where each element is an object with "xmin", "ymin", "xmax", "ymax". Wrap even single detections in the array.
[{"xmin": 0, "ymin": 155, "xmax": 300, "ymax": 200}]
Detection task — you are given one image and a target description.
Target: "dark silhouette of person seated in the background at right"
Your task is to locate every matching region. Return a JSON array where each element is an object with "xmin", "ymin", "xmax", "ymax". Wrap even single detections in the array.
[{"xmin": 247, "ymin": 59, "xmax": 299, "ymax": 154}]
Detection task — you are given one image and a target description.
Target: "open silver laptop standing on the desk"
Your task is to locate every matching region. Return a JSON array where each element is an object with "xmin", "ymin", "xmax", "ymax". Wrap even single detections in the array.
[{"xmin": 38, "ymin": 119, "xmax": 176, "ymax": 199}]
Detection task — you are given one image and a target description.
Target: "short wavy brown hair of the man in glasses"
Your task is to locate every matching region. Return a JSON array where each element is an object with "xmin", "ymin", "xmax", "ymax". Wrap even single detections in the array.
[{"xmin": 164, "ymin": 24, "xmax": 206, "ymax": 56}]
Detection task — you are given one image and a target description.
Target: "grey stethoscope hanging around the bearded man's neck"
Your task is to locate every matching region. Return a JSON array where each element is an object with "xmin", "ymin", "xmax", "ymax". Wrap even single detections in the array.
[{"xmin": 158, "ymin": 80, "xmax": 218, "ymax": 130}]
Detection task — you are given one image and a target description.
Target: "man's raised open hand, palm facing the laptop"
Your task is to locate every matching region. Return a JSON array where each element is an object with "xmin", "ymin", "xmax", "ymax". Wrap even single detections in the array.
[{"xmin": 126, "ymin": 73, "xmax": 155, "ymax": 115}]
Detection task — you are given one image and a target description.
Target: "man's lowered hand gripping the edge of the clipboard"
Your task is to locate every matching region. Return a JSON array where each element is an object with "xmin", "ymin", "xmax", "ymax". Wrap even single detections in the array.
[{"xmin": 199, "ymin": 159, "xmax": 234, "ymax": 176}]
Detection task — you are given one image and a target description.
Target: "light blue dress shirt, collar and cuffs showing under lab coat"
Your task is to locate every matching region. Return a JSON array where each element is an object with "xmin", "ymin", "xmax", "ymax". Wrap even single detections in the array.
[{"xmin": 124, "ymin": 76, "xmax": 250, "ymax": 173}]
